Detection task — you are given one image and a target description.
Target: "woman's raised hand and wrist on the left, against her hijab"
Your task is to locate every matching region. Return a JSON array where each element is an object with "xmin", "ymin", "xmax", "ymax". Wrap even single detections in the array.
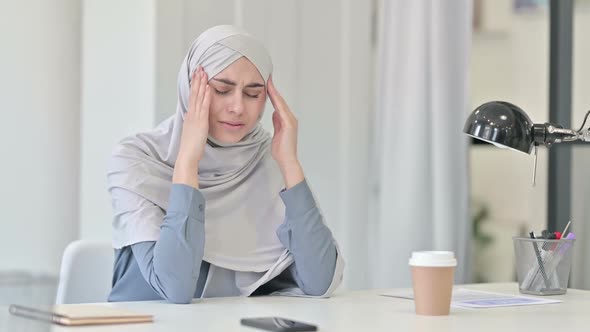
[{"xmin": 172, "ymin": 66, "xmax": 211, "ymax": 189}]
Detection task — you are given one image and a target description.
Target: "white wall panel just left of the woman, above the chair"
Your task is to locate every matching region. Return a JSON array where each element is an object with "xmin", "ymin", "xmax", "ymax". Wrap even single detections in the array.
[{"xmin": 80, "ymin": 0, "xmax": 161, "ymax": 241}]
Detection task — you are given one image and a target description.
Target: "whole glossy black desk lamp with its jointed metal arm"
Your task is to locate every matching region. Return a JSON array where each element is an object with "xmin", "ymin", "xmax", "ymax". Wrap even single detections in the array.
[{"xmin": 463, "ymin": 101, "xmax": 590, "ymax": 184}]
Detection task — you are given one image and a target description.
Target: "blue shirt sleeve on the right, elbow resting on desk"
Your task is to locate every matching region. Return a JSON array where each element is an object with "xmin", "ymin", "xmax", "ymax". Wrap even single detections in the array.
[{"xmin": 277, "ymin": 180, "xmax": 337, "ymax": 296}]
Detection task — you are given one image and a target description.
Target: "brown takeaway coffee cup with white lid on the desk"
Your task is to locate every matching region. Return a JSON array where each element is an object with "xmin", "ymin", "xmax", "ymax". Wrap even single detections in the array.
[{"xmin": 410, "ymin": 251, "xmax": 457, "ymax": 316}]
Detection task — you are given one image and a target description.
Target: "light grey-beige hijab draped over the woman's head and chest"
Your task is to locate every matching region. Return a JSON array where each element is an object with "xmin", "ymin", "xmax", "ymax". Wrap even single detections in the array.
[{"xmin": 107, "ymin": 26, "xmax": 285, "ymax": 272}]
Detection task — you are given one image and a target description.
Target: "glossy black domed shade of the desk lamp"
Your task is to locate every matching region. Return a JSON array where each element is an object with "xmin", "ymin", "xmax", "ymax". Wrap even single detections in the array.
[{"xmin": 463, "ymin": 101, "xmax": 534, "ymax": 154}]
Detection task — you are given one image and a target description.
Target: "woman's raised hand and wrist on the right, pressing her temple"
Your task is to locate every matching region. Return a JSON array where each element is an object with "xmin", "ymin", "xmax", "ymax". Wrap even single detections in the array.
[{"xmin": 267, "ymin": 77, "xmax": 304, "ymax": 189}]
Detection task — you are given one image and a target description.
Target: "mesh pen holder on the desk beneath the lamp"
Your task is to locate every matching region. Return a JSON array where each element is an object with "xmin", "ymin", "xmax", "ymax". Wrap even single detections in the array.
[{"xmin": 512, "ymin": 237, "xmax": 575, "ymax": 295}]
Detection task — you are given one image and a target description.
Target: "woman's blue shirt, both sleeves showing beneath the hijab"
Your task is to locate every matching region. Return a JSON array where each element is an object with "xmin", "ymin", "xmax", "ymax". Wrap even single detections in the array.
[{"xmin": 108, "ymin": 181, "xmax": 337, "ymax": 303}]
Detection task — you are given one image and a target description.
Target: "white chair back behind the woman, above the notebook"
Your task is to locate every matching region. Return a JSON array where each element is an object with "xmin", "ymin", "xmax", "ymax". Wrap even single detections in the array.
[{"xmin": 55, "ymin": 240, "xmax": 115, "ymax": 304}]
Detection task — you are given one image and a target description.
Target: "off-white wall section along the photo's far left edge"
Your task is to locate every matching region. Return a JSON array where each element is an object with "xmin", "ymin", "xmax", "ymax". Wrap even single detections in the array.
[{"xmin": 0, "ymin": 0, "xmax": 80, "ymax": 274}]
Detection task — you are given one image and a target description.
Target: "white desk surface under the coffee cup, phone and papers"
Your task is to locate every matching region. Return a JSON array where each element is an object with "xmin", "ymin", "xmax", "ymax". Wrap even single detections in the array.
[{"xmin": 0, "ymin": 283, "xmax": 590, "ymax": 332}]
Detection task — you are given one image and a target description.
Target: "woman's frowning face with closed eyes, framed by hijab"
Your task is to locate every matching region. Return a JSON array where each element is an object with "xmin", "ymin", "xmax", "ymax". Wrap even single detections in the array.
[{"xmin": 209, "ymin": 57, "xmax": 266, "ymax": 143}]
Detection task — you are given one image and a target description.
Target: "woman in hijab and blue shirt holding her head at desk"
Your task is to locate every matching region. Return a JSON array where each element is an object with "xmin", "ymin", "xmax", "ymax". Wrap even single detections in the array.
[{"xmin": 108, "ymin": 26, "xmax": 344, "ymax": 303}]
